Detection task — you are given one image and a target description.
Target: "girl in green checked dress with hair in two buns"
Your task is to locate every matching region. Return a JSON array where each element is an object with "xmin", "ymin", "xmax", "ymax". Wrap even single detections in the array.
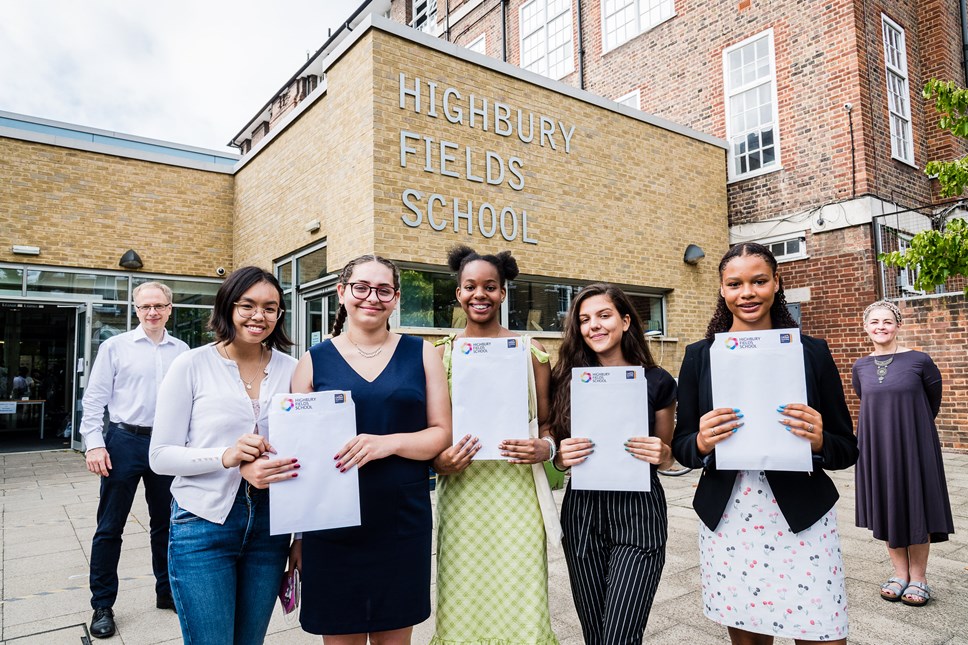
[{"xmin": 431, "ymin": 246, "xmax": 560, "ymax": 645}]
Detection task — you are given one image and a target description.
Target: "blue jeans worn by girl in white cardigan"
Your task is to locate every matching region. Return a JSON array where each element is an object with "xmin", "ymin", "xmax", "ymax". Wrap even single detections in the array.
[{"xmin": 168, "ymin": 481, "xmax": 289, "ymax": 645}]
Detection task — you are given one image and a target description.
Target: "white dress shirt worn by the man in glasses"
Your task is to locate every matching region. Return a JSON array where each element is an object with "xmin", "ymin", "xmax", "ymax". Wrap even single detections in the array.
[{"xmin": 81, "ymin": 325, "xmax": 188, "ymax": 450}]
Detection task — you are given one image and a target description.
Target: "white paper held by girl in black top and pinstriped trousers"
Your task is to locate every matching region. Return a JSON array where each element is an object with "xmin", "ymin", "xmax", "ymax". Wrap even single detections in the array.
[{"xmin": 571, "ymin": 367, "xmax": 651, "ymax": 492}]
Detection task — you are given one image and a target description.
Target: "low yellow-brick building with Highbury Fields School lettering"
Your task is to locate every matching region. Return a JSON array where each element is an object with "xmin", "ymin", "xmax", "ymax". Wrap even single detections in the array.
[{"xmin": 0, "ymin": 15, "xmax": 728, "ymax": 450}]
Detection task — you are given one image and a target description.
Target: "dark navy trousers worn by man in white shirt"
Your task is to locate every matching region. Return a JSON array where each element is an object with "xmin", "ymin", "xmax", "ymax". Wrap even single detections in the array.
[{"xmin": 90, "ymin": 423, "xmax": 173, "ymax": 609}]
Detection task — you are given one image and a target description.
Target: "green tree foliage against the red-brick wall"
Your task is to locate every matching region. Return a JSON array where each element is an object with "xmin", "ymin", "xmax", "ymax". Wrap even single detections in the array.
[{"xmin": 878, "ymin": 79, "xmax": 968, "ymax": 295}]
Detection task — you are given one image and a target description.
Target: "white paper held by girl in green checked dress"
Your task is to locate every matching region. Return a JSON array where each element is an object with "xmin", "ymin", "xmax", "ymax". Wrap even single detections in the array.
[{"xmin": 451, "ymin": 337, "xmax": 531, "ymax": 460}]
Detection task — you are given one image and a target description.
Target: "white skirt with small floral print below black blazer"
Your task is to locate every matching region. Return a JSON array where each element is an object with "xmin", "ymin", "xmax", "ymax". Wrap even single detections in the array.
[{"xmin": 699, "ymin": 470, "xmax": 847, "ymax": 641}]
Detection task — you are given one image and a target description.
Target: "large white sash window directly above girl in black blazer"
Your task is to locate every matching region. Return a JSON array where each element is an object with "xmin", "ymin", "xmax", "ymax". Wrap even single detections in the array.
[{"xmin": 723, "ymin": 29, "xmax": 780, "ymax": 181}]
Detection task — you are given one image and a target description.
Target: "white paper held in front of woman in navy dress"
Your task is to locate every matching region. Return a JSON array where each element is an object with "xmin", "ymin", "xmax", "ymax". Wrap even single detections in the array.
[{"xmin": 268, "ymin": 391, "xmax": 360, "ymax": 535}]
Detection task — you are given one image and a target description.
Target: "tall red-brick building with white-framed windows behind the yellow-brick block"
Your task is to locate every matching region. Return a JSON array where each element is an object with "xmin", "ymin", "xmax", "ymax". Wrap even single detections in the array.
[{"xmin": 292, "ymin": 0, "xmax": 968, "ymax": 449}]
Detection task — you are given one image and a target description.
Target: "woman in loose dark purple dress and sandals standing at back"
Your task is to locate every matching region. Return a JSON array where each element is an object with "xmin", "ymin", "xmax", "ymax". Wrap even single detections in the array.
[{"xmin": 853, "ymin": 300, "xmax": 954, "ymax": 607}]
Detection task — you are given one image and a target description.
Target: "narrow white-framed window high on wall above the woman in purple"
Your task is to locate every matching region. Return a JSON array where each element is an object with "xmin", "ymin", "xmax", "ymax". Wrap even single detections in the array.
[{"xmin": 881, "ymin": 14, "xmax": 914, "ymax": 166}]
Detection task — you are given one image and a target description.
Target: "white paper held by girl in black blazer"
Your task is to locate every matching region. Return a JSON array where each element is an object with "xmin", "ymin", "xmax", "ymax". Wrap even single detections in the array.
[{"xmin": 709, "ymin": 329, "xmax": 813, "ymax": 472}]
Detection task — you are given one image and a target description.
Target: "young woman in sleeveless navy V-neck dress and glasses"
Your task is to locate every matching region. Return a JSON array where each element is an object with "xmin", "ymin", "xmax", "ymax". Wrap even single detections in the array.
[{"xmin": 292, "ymin": 255, "xmax": 451, "ymax": 645}]
